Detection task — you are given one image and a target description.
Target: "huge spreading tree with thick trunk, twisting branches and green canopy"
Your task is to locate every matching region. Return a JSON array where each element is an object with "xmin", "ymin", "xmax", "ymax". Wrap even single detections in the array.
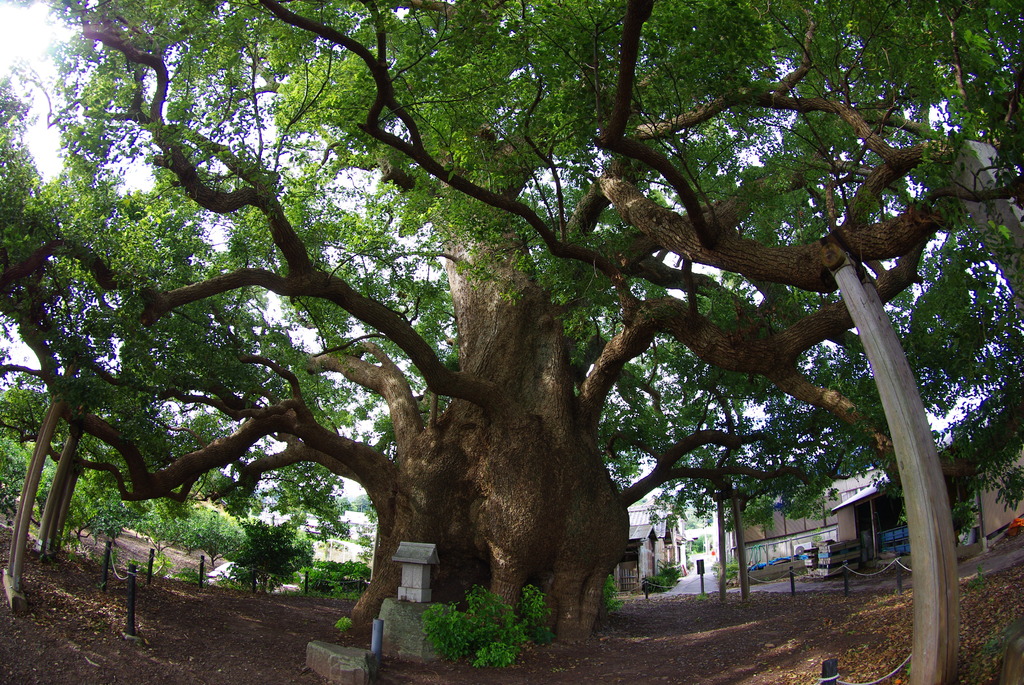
[{"xmin": 0, "ymin": 0, "xmax": 1024, "ymax": 671}]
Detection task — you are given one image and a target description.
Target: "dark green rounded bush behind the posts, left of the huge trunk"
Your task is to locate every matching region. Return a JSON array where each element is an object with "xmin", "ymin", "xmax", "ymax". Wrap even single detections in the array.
[{"xmin": 230, "ymin": 521, "xmax": 313, "ymax": 591}]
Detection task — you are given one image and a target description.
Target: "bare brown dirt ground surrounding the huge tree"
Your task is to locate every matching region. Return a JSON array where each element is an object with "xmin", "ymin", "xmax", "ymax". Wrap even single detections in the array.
[{"xmin": 0, "ymin": 529, "xmax": 1024, "ymax": 685}]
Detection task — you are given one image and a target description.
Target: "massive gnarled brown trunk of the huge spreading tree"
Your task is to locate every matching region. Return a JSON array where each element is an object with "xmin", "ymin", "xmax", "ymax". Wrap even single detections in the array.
[{"xmin": 353, "ymin": 237, "xmax": 628, "ymax": 640}]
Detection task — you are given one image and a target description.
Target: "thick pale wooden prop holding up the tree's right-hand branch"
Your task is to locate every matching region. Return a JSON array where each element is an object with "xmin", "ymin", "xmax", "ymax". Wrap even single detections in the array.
[{"xmin": 822, "ymin": 241, "xmax": 959, "ymax": 685}]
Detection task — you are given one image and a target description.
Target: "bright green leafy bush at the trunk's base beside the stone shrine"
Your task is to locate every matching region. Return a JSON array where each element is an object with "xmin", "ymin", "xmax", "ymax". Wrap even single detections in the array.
[{"xmin": 423, "ymin": 586, "xmax": 554, "ymax": 668}]
